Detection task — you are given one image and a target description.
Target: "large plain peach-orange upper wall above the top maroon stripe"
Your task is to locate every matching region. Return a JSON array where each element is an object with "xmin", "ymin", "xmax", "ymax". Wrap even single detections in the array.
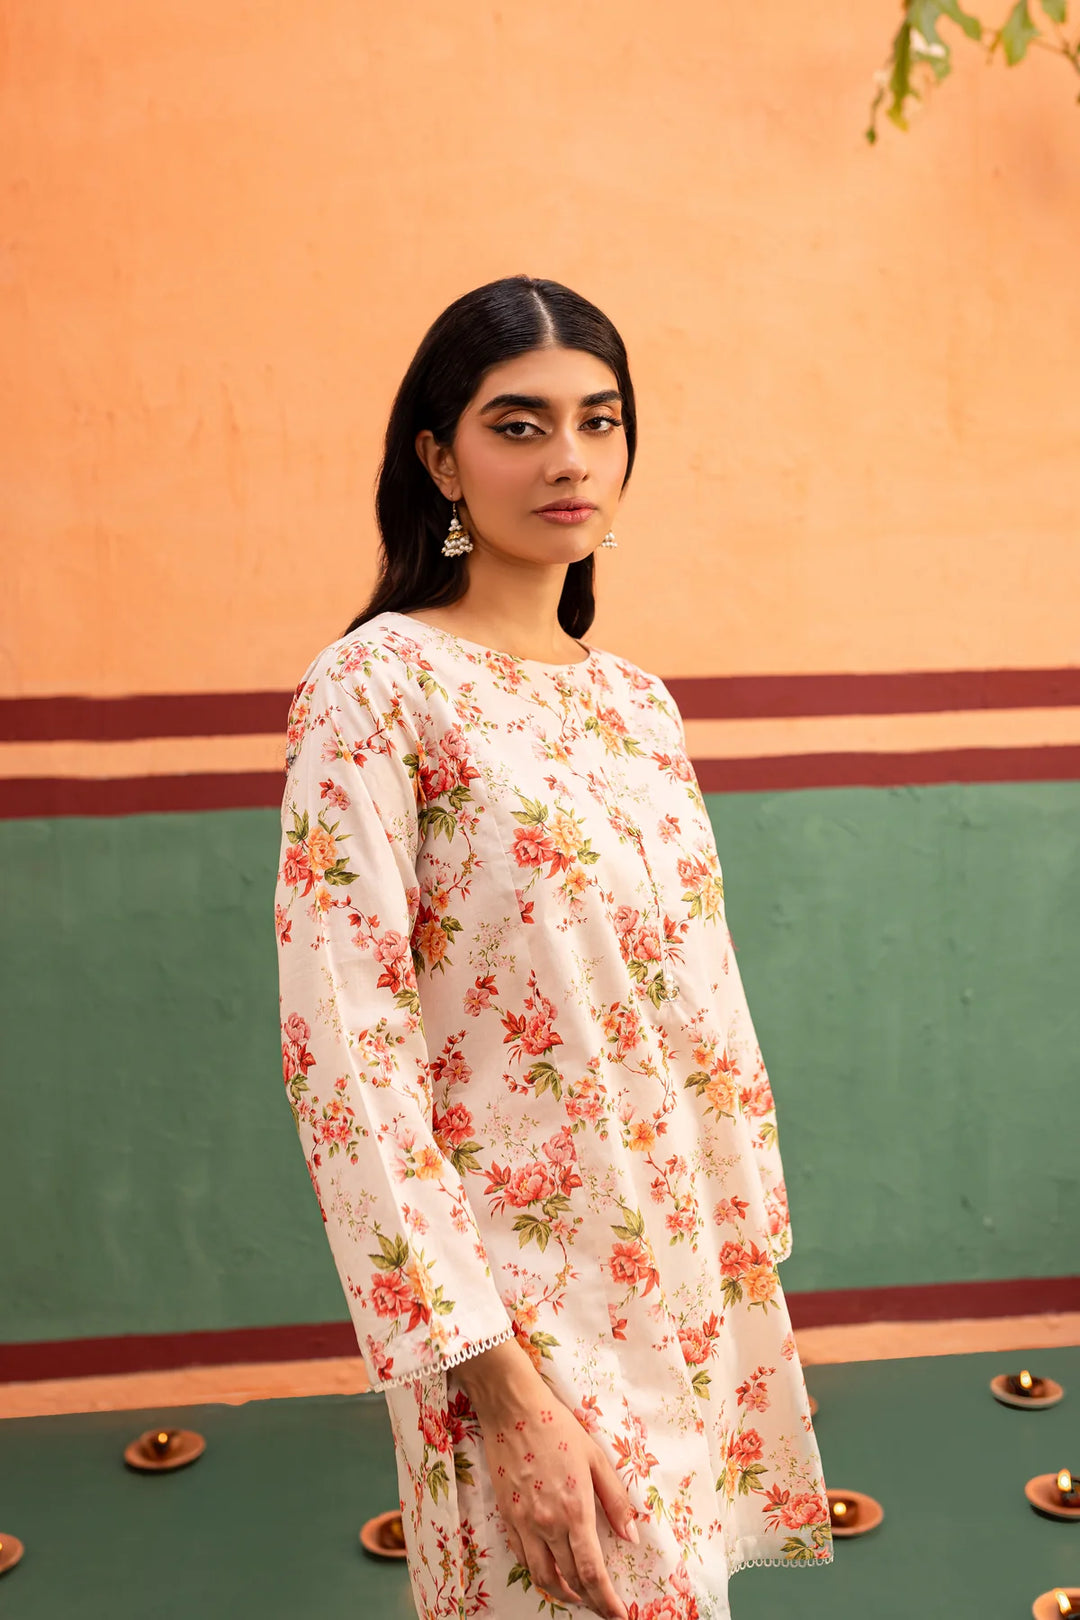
[{"xmin": 0, "ymin": 0, "xmax": 1080, "ymax": 695}]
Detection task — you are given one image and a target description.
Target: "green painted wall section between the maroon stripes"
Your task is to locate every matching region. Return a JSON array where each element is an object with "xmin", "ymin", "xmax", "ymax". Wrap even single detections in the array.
[{"xmin": 0, "ymin": 782, "xmax": 1080, "ymax": 1341}]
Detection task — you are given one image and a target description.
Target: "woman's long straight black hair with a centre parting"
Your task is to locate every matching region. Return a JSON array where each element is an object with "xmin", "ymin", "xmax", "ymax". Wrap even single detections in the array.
[{"xmin": 345, "ymin": 275, "xmax": 636, "ymax": 637}]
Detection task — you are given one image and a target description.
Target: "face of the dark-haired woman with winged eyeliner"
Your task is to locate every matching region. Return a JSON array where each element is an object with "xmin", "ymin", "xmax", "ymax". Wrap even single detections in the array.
[{"xmin": 416, "ymin": 348, "xmax": 627, "ymax": 564}]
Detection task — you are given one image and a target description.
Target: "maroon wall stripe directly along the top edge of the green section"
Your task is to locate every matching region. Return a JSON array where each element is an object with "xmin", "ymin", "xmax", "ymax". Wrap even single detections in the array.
[{"xmin": 0, "ymin": 745, "xmax": 1080, "ymax": 820}]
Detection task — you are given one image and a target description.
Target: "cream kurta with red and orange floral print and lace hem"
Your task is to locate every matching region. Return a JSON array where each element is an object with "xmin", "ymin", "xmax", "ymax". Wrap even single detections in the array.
[{"xmin": 275, "ymin": 612, "xmax": 832, "ymax": 1620}]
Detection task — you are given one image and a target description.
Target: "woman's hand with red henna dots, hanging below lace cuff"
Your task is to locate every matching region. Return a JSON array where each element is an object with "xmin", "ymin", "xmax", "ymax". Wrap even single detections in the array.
[{"xmin": 455, "ymin": 1340, "xmax": 638, "ymax": 1620}]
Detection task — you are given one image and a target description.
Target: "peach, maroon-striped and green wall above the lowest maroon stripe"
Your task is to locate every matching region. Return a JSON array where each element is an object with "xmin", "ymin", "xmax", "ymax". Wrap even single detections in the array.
[{"xmin": 0, "ymin": 0, "xmax": 1080, "ymax": 1341}]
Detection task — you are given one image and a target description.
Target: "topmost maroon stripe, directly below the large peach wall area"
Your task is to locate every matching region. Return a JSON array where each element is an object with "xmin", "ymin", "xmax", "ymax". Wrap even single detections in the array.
[{"xmin": 0, "ymin": 667, "xmax": 1080, "ymax": 742}]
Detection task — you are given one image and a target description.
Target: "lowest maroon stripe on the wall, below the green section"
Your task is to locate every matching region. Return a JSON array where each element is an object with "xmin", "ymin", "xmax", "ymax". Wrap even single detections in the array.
[{"xmin": 0, "ymin": 1277, "xmax": 1080, "ymax": 1383}]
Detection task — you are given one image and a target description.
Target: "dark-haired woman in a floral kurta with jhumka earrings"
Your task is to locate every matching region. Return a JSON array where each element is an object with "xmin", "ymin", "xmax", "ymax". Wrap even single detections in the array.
[{"xmin": 277, "ymin": 277, "xmax": 832, "ymax": 1620}]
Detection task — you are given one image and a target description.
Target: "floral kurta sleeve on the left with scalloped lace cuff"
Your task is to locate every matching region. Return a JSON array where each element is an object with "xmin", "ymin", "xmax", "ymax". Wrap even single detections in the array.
[{"xmin": 275, "ymin": 643, "xmax": 513, "ymax": 1388}]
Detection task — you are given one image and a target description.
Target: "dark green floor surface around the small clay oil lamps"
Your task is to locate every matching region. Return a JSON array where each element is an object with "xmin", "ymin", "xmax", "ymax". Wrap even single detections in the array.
[{"xmin": 0, "ymin": 1348, "xmax": 1080, "ymax": 1620}]
